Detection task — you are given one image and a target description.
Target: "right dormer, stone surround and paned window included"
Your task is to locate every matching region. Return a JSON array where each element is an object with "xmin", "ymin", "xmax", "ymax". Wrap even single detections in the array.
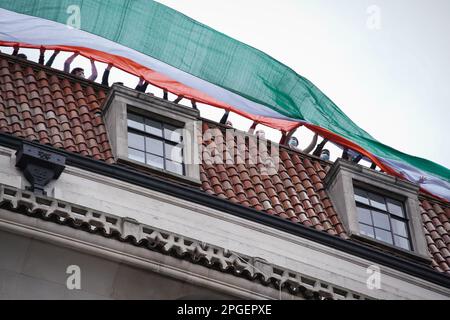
[{"xmin": 325, "ymin": 159, "xmax": 429, "ymax": 260}]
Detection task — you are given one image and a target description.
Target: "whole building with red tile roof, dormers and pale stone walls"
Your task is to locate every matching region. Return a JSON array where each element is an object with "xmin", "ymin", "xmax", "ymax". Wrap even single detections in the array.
[{"xmin": 0, "ymin": 54, "xmax": 450, "ymax": 299}]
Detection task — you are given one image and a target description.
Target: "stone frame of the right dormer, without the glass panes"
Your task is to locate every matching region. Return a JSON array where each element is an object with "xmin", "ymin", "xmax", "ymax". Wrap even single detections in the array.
[{"xmin": 325, "ymin": 159, "xmax": 430, "ymax": 261}]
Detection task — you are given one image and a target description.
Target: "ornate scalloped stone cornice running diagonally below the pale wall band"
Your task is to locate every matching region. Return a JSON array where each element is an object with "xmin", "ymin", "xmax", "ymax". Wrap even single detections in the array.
[{"xmin": 0, "ymin": 185, "xmax": 369, "ymax": 300}]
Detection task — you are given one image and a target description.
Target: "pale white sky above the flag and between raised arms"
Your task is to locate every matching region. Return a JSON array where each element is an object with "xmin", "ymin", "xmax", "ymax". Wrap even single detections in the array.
[{"xmin": 1, "ymin": 0, "xmax": 450, "ymax": 168}]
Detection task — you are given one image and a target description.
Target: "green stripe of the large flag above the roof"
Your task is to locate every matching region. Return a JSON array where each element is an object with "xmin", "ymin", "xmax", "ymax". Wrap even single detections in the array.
[{"xmin": 0, "ymin": 0, "xmax": 450, "ymax": 192}]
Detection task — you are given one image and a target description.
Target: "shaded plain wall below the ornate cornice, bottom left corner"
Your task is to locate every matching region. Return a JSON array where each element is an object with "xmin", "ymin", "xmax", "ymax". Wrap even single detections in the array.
[{"xmin": 0, "ymin": 230, "xmax": 239, "ymax": 300}]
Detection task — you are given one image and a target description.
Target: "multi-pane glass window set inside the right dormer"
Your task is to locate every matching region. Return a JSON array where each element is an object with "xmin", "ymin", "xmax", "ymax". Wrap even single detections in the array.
[{"xmin": 354, "ymin": 188, "xmax": 411, "ymax": 250}]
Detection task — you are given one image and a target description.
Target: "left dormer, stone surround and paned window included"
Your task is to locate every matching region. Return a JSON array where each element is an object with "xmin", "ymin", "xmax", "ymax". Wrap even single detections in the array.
[{"xmin": 103, "ymin": 85, "xmax": 201, "ymax": 185}]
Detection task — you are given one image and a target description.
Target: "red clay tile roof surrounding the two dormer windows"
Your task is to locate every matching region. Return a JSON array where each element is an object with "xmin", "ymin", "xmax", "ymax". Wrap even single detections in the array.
[{"xmin": 0, "ymin": 54, "xmax": 450, "ymax": 274}]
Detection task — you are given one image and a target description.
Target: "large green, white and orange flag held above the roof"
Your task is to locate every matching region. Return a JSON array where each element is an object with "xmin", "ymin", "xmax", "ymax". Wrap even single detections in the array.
[{"xmin": 0, "ymin": 0, "xmax": 450, "ymax": 201}]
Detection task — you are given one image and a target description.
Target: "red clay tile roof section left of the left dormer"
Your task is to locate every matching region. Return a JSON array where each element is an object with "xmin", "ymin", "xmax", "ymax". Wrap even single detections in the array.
[{"xmin": 0, "ymin": 56, "xmax": 113, "ymax": 163}]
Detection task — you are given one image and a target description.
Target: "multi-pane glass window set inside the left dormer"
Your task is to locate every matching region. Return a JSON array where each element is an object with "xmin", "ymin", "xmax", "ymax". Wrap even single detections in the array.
[{"xmin": 128, "ymin": 113, "xmax": 184, "ymax": 174}]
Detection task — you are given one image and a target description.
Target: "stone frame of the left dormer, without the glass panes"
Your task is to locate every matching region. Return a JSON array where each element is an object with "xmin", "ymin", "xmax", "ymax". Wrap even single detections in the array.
[{"xmin": 103, "ymin": 84, "xmax": 201, "ymax": 185}]
